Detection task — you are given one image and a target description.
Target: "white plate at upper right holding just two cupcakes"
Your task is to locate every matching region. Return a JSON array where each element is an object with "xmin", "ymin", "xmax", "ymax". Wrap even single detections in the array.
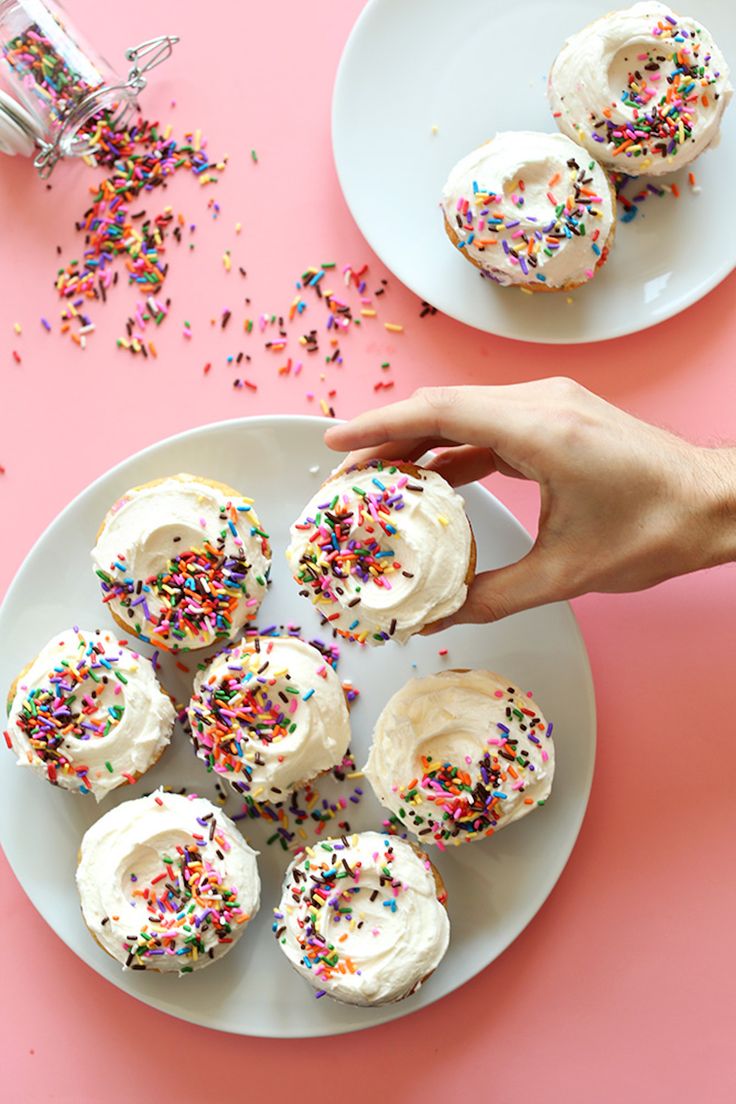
[{"xmin": 332, "ymin": 0, "xmax": 736, "ymax": 343}]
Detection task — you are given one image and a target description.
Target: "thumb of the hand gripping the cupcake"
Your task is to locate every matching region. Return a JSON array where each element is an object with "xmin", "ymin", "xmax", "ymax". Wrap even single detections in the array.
[{"xmin": 424, "ymin": 544, "xmax": 567, "ymax": 634}]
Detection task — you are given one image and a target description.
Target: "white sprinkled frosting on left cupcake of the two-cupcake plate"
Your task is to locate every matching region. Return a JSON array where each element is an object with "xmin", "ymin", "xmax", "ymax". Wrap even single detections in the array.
[{"xmin": 441, "ymin": 130, "xmax": 616, "ymax": 288}]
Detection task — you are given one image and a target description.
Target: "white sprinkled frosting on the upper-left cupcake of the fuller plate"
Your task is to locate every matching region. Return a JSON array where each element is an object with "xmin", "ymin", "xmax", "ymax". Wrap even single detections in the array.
[{"xmin": 92, "ymin": 475, "xmax": 270, "ymax": 651}]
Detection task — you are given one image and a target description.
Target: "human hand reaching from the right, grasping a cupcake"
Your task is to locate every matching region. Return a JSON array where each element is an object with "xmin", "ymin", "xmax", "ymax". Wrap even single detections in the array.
[{"xmin": 324, "ymin": 379, "xmax": 736, "ymax": 629}]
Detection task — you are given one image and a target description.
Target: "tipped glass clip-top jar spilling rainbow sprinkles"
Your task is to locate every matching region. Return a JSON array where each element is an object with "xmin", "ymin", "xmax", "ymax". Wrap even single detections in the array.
[{"xmin": 0, "ymin": 0, "xmax": 179, "ymax": 177}]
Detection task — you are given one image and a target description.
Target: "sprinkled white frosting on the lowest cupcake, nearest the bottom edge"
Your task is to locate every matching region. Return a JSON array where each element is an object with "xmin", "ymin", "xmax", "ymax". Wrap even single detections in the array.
[{"xmin": 274, "ymin": 831, "xmax": 450, "ymax": 1005}]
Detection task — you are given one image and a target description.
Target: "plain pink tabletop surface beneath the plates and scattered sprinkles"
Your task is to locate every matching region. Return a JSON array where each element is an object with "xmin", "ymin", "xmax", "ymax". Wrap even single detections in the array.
[{"xmin": 0, "ymin": 0, "xmax": 736, "ymax": 1104}]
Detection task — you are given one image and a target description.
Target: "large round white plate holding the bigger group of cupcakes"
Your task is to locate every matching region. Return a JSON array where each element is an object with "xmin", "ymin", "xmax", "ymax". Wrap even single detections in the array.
[{"xmin": 0, "ymin": 416, "xmax": 595, "ymax": 1036}]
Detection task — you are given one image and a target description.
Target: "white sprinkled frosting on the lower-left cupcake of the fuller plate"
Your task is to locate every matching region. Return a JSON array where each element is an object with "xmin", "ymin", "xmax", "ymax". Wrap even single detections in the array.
[{"xmin": 76, "ymin": 790, "xmax": 260, "ymax": 973}]
